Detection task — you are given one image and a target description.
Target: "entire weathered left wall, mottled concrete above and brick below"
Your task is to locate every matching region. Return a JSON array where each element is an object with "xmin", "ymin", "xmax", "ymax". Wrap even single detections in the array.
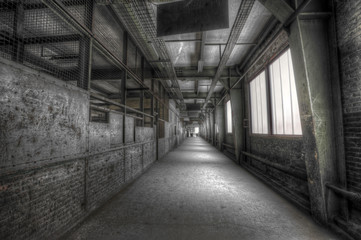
[{"xmin": 0, "ymin": 60, "xmax": 161, "ymax": 239}]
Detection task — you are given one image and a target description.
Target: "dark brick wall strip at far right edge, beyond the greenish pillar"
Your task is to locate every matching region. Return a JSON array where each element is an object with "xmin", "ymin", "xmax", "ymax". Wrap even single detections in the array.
[{"xmin": 335, "ymin": 1, "xmax": 361, "ymax": 218}]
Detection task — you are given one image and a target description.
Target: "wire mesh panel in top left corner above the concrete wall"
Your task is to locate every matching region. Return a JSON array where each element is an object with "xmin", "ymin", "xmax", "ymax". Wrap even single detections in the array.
[{"xmin": 0, "ymin": 0, "xmax": 88, "ymax": 81}]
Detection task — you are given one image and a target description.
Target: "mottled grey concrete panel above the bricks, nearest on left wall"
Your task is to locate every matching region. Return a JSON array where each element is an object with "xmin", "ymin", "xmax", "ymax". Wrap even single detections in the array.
[{"xmin": 0, "ymin": 60, "xmax": 89, "ymax": 167}]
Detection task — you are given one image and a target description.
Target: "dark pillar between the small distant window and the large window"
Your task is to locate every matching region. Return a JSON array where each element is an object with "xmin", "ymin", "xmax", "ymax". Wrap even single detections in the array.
[{"xmin": 230, "ymin": 88, "xmax": 244, "ymax": 163}]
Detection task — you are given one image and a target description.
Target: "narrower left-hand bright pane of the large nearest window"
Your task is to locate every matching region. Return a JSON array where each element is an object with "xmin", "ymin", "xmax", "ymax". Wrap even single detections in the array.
[{"xmin": 250, "ymin": 71, "xmax": 268, "ymax": 134}]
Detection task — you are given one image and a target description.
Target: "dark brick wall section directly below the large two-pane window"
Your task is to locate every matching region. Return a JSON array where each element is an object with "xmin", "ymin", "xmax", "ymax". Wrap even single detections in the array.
[{"xmin": 249, "ymin": 135, "xmax": 310, "ymax": 211}]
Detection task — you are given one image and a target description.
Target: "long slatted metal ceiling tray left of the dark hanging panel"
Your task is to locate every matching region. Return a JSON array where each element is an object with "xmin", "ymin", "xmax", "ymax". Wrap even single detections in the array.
[{"xmin": 111, "ymin": 0, "xmax": 186, "ymax": 109}]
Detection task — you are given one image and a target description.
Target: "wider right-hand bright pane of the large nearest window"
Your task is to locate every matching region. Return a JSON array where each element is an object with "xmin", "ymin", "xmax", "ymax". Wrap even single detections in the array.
[{"xmin": 269, "ymin": 50, "xmax": 302, "ymax": 135}]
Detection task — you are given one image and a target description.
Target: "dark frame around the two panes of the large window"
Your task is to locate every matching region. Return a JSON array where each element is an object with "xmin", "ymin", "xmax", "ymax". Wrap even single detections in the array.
[{"xmin": 247, "ymin": 46, "xmax": 303, "ymax": 139}]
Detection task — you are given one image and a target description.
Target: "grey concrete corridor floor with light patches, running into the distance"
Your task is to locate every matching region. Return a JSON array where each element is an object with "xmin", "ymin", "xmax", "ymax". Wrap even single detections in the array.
[{"xmin": 67, "ymin": 137, "xmax": 339, "ymax": 240}]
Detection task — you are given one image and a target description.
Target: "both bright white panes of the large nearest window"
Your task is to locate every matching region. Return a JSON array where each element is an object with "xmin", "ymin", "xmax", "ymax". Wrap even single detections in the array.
[{"xmin": 250, "ymin": 49, "xmax": 302, "ymax": 135}]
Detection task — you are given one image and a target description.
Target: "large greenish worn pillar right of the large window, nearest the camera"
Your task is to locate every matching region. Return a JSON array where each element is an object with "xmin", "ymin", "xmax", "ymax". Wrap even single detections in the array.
[{"xmin": 289, "ymin": 2, "xmax": 338, "ymax": 223}]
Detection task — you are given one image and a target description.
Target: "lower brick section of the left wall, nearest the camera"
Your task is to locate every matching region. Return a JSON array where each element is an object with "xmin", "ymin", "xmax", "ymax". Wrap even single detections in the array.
[{"xmin": 0, "ymin": 159, "xmax": 85, "ymax": 239}]
